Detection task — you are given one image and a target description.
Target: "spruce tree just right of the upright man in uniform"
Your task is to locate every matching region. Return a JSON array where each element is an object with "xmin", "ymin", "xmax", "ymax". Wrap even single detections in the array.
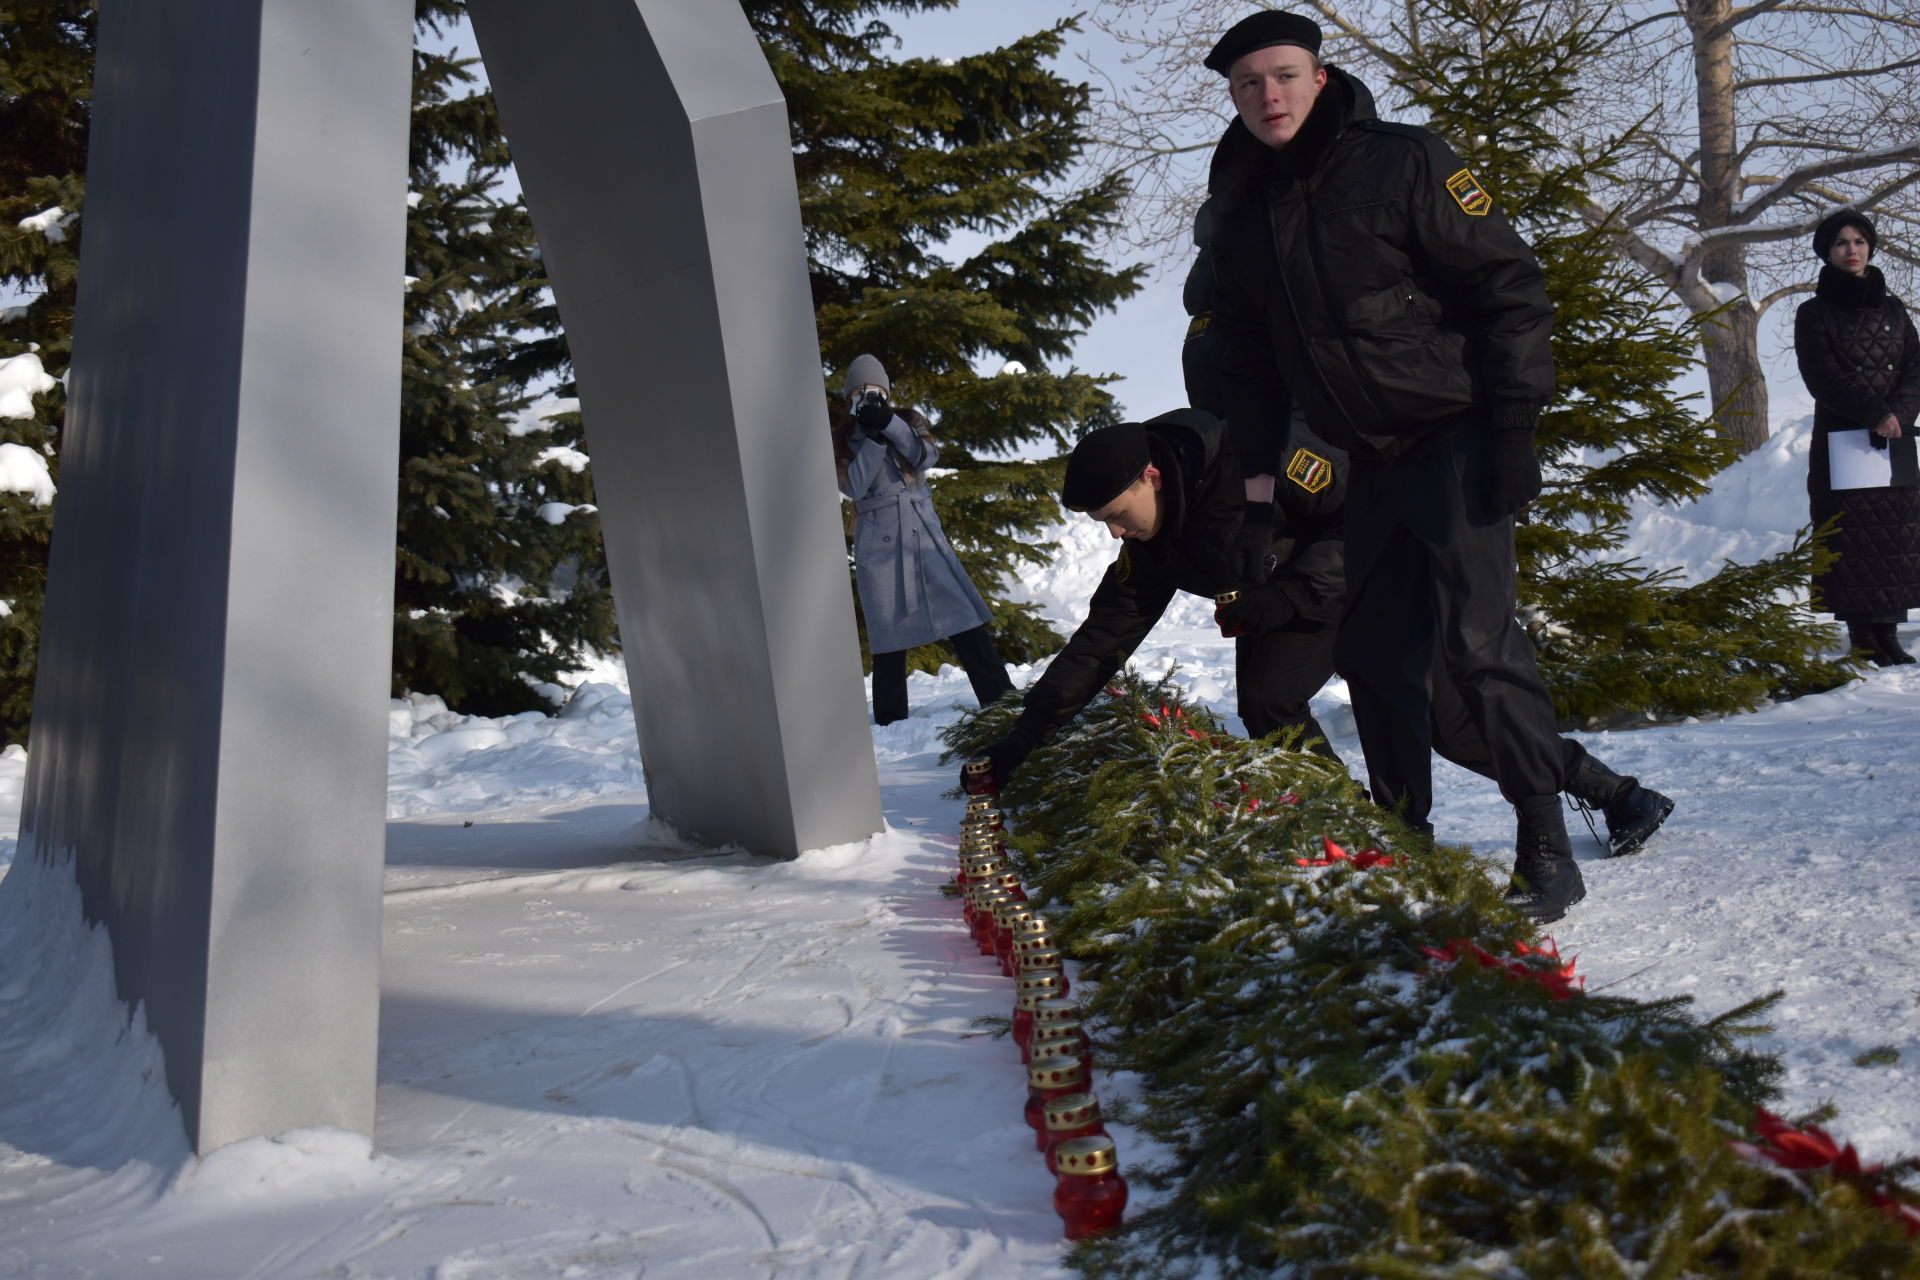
[{"xmin": 1394, "ymin": 0, "xmax": 1853, "ymax": 723}]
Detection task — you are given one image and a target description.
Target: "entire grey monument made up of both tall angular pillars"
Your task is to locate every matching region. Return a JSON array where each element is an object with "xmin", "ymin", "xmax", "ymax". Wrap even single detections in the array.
[{"xmin": 19, "ymin": 0, "xmax": 879, "ymax": 1151}]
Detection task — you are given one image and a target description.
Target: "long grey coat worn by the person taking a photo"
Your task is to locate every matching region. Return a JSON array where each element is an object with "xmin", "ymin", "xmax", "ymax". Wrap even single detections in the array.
[{"xmin": 841, "ymin": 415, "xmax": 993, "ymax": 652}]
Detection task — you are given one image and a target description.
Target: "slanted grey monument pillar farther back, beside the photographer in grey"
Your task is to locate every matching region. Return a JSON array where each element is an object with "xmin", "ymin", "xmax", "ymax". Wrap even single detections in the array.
[{"xmin": 468, "ymin": 0, "xmax": 879, "ymax": 854}]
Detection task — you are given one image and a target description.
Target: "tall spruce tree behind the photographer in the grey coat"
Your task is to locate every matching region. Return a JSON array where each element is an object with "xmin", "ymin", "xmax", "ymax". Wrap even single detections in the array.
[{"xmin": 745, "ymin": 0, "xmax": 1142, "ymax": 670}]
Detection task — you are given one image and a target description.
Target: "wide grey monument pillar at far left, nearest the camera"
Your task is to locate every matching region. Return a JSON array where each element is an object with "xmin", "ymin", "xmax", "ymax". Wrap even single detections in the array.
[{"xmin": 19, "ymin": 0, "xmax": 413, "ymax": 1151}]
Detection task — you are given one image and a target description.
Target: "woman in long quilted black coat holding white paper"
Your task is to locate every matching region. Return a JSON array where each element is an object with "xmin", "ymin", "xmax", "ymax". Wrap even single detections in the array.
[{"xmin": 1793, "ymin": 209, "xmax": 1920, "ymax": 666}]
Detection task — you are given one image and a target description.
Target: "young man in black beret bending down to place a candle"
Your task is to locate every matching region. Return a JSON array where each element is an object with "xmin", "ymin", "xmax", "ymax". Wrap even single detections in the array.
[{"xmin": 985, "ymin": 409, "xmax": 1344, "ymax": 783}]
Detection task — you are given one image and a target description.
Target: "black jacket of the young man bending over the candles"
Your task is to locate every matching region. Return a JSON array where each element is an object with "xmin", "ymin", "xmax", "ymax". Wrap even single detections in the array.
[{"xmin": 1020, "ymin": 409, "xmax": 1346, "ymax": 741}]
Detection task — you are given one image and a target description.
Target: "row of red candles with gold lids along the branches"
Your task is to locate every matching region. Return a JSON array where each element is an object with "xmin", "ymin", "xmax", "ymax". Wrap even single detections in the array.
[{"xmin": 956, "ymin": 758, "xmax": 1127, "ymax": 1240}]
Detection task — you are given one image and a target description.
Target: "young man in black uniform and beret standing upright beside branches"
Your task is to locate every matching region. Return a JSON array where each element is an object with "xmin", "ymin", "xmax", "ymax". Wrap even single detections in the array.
[{"xmin": 1206, "ymin": 10, "xmax": 1620, "ymax": 909}]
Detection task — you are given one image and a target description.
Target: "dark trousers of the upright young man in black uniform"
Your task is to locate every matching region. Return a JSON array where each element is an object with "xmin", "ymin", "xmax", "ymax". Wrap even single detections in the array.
[{"xmin": 1334, "ymin": 428, "xmax": 1567, "ymax": 823}]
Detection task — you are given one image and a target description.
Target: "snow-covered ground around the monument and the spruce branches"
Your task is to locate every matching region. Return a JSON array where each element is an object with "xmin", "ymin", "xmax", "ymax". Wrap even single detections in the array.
[{"xmin": 0, "ymin": 424, "xmax": 1920, "ymax": 1280}]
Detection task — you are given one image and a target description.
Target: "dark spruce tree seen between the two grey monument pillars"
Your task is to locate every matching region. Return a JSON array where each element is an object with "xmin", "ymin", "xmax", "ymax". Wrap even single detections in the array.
[{"xmin": 394, "ymin": 0, "xmax": 614, "ymax": 716}]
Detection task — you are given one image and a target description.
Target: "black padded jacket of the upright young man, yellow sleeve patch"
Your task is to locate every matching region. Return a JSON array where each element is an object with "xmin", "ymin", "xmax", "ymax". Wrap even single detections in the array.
[{"xmin": 1208, "ymin": 67, "xmax": 1553, "ymax": 474}]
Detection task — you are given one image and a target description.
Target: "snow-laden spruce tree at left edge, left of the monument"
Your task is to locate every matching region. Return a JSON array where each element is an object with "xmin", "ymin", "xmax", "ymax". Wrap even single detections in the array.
[{"xmin": 0, "ymin": 0, "xmax": 94, "ymax": 743}]
